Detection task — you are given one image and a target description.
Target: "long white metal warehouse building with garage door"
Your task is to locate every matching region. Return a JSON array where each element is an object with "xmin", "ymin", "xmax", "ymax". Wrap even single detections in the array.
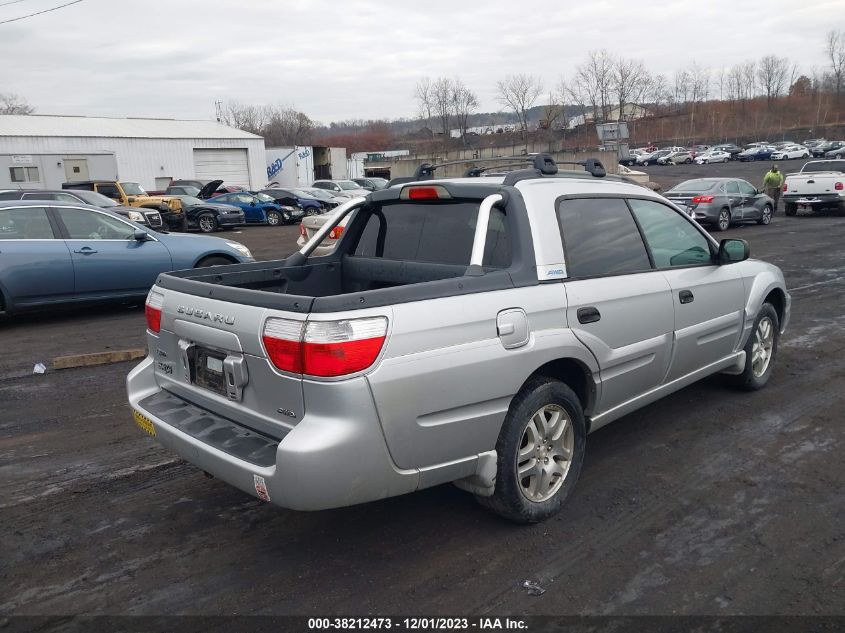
[{"xmin": 0, "ymin": 115, "xmax": 267, "ymax": 191}]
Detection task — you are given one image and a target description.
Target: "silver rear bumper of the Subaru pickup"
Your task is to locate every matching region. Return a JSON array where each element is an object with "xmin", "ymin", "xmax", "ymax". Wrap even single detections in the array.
[{"xmin": 126, "ymin": 357, "xmax": 419, "ymax": 510}]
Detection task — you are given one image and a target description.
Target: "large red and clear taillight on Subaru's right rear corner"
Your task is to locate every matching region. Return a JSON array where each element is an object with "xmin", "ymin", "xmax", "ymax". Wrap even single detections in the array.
[{"xmin": 262, "ymin": 317, "xmax": 387, "ymax": 378}]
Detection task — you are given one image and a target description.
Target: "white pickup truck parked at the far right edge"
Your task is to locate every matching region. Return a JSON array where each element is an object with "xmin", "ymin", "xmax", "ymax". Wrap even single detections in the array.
[{"xmin": 783, "ymin": 160, "xmax": 845, "ymax": 215}]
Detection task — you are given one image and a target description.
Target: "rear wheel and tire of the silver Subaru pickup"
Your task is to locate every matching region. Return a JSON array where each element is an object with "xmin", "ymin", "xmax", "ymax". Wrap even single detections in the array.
[{"xmin": 477, "ymin": 376, "xmax": 587, "ymax": 523}]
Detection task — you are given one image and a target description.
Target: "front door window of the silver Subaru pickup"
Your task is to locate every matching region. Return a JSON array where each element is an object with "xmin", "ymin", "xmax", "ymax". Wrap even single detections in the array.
[{"xmin": 628, "ymin": 200, "xmax": 712, "ymax": 268}]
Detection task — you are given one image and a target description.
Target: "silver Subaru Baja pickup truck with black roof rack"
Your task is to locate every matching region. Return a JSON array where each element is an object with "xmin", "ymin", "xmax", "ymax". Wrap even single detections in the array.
[{"xmin": 127, "ymin": 155, "xmax": 790, "ymax": 522}]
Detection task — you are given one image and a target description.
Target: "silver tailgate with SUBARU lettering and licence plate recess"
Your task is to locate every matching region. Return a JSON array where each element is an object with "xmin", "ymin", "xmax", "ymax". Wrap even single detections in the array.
[{"xmin": 148, "ymin": 287, "xmax": 307, "ymax": 439}]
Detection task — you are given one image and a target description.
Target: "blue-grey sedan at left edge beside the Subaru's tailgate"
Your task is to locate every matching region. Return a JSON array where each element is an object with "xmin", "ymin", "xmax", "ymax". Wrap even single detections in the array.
[{"xmin": 0, "ymin": 200, "xmax": 253, "ymax": 314}]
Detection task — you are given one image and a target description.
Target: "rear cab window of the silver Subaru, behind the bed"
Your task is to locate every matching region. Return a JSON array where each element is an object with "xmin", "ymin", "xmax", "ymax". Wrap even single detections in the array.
[{"xmin": 355, "ymin": 202, "xmax": 511, "ymax": 268}]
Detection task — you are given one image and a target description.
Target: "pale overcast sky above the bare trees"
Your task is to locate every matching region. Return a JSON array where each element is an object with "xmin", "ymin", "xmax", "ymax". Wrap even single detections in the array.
[{"xmin": 0, "ymin": 0, "xmax": 845, "ymax": 123}]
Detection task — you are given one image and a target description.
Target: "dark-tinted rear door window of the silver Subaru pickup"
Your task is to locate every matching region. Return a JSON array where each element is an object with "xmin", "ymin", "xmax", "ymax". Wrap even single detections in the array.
[{"xmin": 558, "ymin": 198, "xmax": 651, "ymax": 277}]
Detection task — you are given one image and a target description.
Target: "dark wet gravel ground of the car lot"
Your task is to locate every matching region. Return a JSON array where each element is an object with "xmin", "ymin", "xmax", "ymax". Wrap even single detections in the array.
[{"xmin": 0, "ymin": 162, "xmax": 845, "ymax": 615}]
